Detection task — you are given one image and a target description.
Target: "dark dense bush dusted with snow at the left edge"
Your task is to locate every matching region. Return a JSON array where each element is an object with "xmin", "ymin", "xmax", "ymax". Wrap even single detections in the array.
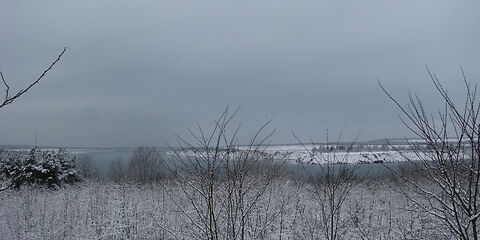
[{"xmin": 0, "ymin": 149, "xmax": 80, "ymax": 188}]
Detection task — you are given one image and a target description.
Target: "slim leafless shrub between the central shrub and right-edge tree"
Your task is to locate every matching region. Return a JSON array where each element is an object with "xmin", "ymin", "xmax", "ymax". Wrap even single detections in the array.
[{"xmin": 292, "ymin": 132, "xmax": 359, "ymax": 240}]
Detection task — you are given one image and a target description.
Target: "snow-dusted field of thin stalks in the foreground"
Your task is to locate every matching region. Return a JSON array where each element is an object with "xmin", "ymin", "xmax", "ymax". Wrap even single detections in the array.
[{"xmin": 0, "ymin": 178, "xmax": 448, "ymax": 240}]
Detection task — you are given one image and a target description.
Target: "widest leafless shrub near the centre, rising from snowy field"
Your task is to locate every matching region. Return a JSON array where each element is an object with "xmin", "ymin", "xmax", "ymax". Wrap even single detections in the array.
[{"xmin": 169, "ymin": 108, "xmax": 287, "ymax": 240}]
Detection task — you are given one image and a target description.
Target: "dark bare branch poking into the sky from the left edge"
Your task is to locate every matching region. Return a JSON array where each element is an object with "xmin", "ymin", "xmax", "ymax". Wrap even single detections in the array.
[{"xmin": 0, "ymin": 47, "xmax": 67, "ymax": 192}]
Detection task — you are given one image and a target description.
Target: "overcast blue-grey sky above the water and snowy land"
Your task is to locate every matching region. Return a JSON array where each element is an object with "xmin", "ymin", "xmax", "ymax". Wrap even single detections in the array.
[{"xmin": 0, "ymin": 0, "xmax": 480, "ymax": 146}]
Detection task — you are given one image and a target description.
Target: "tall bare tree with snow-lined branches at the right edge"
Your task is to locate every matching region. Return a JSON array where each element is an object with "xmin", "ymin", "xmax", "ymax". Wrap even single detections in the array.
[{"xmin": 379, "ymin": 67, "xmax": 480, "ymax": 240}]
